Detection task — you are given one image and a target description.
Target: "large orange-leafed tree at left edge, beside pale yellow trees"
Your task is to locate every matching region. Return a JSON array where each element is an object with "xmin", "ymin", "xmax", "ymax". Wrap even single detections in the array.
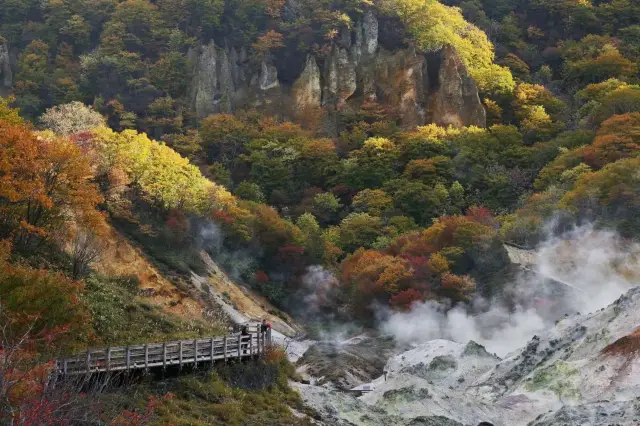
[{"xmin": 0, "ymin": 120, "xmax": 104, "ymax": 245}]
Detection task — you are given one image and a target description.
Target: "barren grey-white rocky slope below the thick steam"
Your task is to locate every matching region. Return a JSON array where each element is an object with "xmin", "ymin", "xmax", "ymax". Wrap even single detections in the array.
[{"xmin": 299, "ymin": 288, "xmax": 640, "ymax": 426}]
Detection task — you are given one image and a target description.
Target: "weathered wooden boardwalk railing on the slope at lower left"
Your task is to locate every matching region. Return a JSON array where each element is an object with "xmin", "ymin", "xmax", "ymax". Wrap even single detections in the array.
[{"xmin": 56, "ymin": 330, "xmax": 271, "ymax": 377}]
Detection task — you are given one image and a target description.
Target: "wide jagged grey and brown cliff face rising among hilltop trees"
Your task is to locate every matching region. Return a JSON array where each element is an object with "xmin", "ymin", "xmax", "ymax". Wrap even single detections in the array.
[{"xmin": 189, "ymin": 11, "xmax": 486, "ymax": 133}]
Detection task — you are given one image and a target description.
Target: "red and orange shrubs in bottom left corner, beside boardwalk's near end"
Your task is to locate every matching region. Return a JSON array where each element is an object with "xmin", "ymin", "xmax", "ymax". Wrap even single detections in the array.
[{"xmin": 0, "ymin": 311, "xmax": 173, "ymax": 426}]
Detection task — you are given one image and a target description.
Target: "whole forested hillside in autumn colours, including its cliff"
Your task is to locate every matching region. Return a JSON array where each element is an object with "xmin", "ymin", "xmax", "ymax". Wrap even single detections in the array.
[{"xmin": 0, "ymin": 0, "xmax": 640, "ymax": 424}]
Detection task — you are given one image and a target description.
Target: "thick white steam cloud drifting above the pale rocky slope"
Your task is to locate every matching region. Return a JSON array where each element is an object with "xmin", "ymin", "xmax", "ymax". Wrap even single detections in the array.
[{"xmin": 381, "ymin": 226, "xmax": 640, "ymax": 357}]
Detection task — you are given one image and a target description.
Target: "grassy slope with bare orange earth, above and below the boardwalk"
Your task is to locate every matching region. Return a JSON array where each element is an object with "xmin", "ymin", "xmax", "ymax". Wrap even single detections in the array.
[{"xmin": 85, "ymin": 223, "xmax": 313, "ymax": 426}]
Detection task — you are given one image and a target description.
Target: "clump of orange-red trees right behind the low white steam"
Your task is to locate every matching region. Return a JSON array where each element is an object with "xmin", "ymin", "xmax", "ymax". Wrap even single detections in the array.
[{"xmin": 342, "ymin": 208, "xmax": 488, "ymax": 315}]
